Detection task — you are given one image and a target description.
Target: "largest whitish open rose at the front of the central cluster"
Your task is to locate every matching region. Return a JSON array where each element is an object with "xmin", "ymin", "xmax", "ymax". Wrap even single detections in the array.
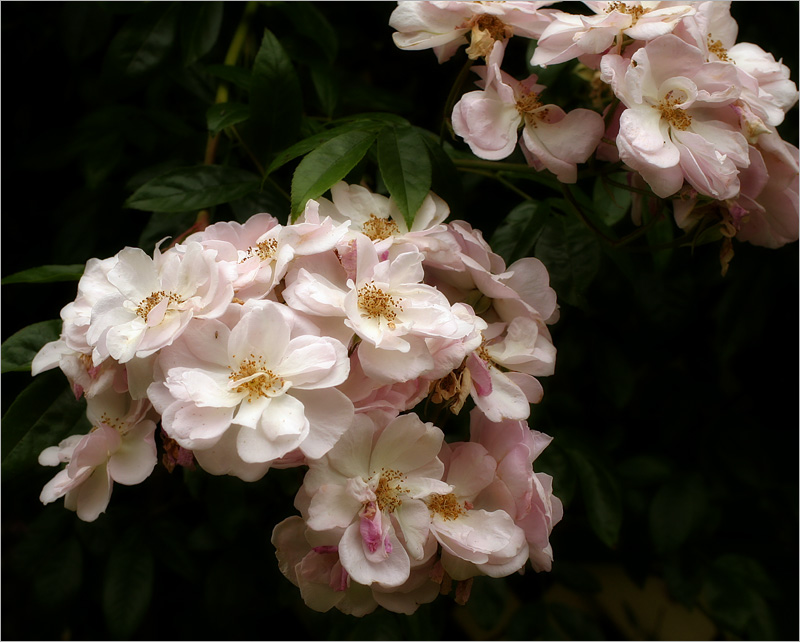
[{"xmin": 148, "ymin": 301, "xmax": 353, "ymax": 477}]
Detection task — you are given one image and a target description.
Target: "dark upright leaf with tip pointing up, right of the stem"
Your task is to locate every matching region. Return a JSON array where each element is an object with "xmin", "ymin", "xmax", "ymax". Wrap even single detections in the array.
[{"xmin": 250, "ymin": 29, "xmax": 303, "ymax": 157}]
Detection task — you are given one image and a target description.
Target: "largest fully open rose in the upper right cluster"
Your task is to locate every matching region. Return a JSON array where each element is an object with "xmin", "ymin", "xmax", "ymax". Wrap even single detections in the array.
[{"xmin": 601, "ymin": 35, "xmax": 750, "ymax": 200}]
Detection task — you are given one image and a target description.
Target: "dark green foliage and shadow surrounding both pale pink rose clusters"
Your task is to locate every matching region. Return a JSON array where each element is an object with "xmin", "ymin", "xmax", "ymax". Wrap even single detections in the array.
[{"xmin": 0, "ymin": 2, "xmax": 798, "ymax": 640}]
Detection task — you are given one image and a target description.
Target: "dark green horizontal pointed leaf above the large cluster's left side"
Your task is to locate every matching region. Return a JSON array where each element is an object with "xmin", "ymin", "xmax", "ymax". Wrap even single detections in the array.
[{"xmin": 125, "ymin": 165, "xmax": 261, "ymax": 212}]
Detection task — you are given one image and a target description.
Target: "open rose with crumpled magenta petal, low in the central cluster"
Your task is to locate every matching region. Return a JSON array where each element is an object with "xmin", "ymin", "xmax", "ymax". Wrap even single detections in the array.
[{"xmin": 302, "ymin": 414, "xmax": 451, "ymax": 587}]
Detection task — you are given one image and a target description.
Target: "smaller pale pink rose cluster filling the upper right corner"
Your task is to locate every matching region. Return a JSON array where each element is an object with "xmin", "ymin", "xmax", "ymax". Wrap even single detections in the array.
[{"xmin": 390, "ymin": 0, "xmax": 798, "ymax": 248}]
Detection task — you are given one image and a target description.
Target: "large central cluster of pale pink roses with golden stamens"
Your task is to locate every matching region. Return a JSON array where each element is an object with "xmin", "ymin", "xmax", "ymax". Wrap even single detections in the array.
[{"xmin": 32, "ymin": 182, "xmax": 562, "ymax": 615}]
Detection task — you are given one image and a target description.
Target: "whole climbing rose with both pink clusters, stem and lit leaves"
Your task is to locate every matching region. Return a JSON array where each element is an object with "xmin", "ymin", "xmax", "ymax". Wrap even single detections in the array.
[{"xmin": 3, "ymin": 1, "xmax": 798, "ymax": 628}]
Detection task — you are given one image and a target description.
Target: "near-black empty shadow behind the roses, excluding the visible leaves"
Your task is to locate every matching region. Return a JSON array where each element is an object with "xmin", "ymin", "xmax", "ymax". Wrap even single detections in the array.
[{"xmin": 2, "ymin": 2, "xmax": 798, "ymax": 639}]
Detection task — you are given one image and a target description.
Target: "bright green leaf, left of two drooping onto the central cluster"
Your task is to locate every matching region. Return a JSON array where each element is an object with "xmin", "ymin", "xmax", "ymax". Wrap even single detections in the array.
[{"xmin": 292, "ymin": 130, "xmax": 376, "ymax": 220}]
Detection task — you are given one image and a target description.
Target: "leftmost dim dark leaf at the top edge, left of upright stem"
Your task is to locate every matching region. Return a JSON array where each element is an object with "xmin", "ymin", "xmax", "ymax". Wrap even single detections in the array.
[{"xmin": 108, "ymin": 2, "xmax": 179, "ymax": 76}]
